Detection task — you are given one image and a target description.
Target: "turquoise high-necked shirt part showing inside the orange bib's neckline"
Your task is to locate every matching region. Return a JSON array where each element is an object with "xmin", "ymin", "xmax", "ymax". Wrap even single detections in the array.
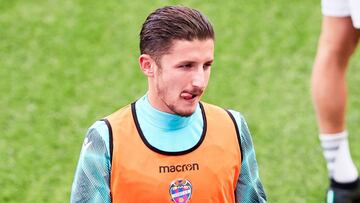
[{"xmin": 135, "ymin": 95, "xmax": 203, "ymax": 152}]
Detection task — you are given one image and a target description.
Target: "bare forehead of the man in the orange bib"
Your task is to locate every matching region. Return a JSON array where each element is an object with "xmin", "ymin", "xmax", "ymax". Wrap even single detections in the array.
[{"xmin": 161, "ymin": 39, "xmax": 214, "ymax": 61}]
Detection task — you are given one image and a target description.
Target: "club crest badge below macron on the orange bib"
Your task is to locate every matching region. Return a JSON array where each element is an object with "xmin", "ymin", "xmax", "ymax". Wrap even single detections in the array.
[{"xmin": 170, "ymin": 179, "xmax": 192, "ymax": 203}]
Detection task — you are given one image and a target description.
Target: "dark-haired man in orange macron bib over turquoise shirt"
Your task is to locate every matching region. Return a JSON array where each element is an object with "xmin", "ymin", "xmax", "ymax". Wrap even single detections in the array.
[{"xmin": 71, "ymin": 6, "xmax": 266, "ymax": 203}]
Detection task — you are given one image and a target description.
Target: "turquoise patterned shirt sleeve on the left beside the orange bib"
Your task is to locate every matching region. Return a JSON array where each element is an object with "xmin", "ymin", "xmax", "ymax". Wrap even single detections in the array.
[{"xmin": 70, "ymin": 121, "xmax": 111, "ymax": 203}]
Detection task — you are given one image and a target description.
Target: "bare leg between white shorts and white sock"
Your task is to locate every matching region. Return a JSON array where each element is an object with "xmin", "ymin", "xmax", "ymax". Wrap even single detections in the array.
[{"xmin": 311, "ymin": 16, "xmax": 360, "ymax": 133}]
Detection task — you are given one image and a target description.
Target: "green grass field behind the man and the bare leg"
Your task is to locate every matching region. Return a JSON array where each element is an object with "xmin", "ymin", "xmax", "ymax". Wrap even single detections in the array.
[{"xmin": 0, "ymin": 0, "xmax": 360, "ymax": 202}]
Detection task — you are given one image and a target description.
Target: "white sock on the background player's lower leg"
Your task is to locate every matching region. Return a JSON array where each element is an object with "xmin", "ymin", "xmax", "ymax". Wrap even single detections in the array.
[{"xmin": 320, "ymin": 131, "xmax": 358, "ymax": 183}]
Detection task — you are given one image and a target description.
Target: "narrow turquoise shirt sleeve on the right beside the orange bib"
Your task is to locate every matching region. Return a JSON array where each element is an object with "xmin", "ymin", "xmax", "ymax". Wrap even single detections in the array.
[{"xmin": 230, "ymin": 111, "xmax": 267, "ymax": 203}]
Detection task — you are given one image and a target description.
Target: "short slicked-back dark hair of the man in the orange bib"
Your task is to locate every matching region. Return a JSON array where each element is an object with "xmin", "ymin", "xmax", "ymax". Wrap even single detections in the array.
[{"xmin": 140, "ymin": 6, "xmax": 215, "ymax": 61}]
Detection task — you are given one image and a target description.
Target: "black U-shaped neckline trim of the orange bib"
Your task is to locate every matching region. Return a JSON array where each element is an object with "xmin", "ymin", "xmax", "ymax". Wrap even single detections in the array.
[{"xmin": 131, "ymin": 102, "xmax": 207, "ymax": 156}]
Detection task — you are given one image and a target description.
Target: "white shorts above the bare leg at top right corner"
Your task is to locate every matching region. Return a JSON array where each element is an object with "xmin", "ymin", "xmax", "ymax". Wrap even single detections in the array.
[{"xmin": 321, "ymin": 0, "xmax": 360, "ymax": 29}]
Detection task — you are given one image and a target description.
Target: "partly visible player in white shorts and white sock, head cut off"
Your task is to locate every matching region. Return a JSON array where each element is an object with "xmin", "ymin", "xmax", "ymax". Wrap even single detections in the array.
[{"xmin": 312, "ymin": 0, "xmax": 360, "ymax": 202}]
